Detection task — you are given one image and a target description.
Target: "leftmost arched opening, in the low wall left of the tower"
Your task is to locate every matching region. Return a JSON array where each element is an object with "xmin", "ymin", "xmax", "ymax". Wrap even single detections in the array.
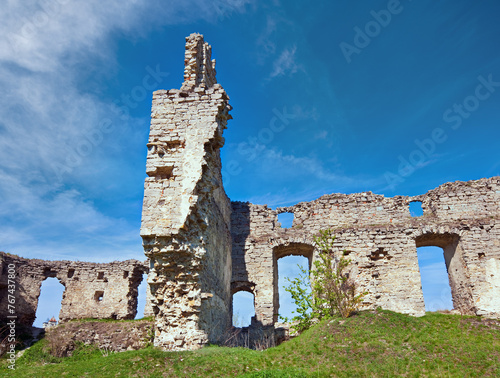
[{"xmin": 33, "ymin": 277, "xmax": 65, "ymax": 327}]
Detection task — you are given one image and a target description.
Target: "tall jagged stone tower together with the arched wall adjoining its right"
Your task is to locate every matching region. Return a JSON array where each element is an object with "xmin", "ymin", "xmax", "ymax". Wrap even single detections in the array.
[{"xmin": 141, "ymin": 34, "xmax": 500, "ymax": 350}]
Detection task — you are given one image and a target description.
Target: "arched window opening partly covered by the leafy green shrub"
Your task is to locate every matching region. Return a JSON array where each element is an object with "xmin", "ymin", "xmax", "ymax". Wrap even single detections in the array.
[{"xmin": 278, "ymin": 256, "xmax": 311, "ymax": 321}]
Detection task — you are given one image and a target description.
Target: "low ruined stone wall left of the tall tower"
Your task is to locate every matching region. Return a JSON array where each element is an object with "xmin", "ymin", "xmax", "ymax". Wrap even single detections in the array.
[{"xmin": 0, "ymin": 252, "xmax": 148, "ymax": 325}]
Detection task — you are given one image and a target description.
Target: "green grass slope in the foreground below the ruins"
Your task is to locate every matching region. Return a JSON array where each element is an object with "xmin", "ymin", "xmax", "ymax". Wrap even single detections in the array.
[{"xmin": 0, "ymin": 311, "xmax": 500, "ymax": 378}]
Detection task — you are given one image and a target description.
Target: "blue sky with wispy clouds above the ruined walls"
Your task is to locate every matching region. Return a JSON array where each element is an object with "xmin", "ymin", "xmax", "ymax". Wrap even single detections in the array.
[{"xmin": 0, "ymin": 0, "xmax": 500, "ymax": 324}]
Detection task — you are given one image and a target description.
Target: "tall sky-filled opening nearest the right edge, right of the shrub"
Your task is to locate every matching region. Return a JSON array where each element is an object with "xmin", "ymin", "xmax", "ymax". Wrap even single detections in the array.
[{"xmin": 417, "ymin": 246, "xmax": 453, "ymax": 311}]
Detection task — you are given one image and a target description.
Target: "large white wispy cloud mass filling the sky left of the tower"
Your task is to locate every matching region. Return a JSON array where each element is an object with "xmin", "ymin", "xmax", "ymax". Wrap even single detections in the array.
[{"xmin": 0, "ymin": 0, "xmax": 251, "ymax": 261}]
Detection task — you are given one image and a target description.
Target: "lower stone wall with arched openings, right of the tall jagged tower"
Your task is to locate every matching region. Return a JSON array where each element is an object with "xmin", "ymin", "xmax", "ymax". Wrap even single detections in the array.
[{"xmin": 232, "ymin": 177, "xmax": 500, "ymax": 325}]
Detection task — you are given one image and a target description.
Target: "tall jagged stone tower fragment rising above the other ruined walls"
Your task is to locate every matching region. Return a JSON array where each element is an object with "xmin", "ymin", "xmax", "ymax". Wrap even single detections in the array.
[{"xmin": 141, "ymin": 34, "xmax": 232, "ymax": 350}]
